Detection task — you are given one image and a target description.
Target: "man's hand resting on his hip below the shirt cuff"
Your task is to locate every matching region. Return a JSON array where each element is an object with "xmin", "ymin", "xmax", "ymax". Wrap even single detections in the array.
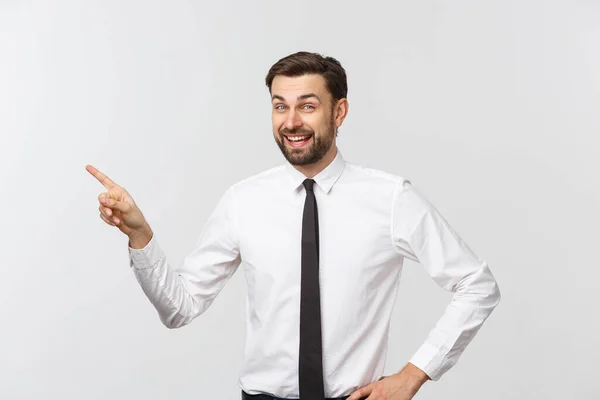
[{"xmin": 348, "ymin": 363, "xmax": 429, "ymax": 400}]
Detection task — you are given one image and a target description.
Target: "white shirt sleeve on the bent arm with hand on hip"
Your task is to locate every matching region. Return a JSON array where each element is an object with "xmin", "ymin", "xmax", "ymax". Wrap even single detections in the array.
[{"xmin": 392, "ymin": 180, "xmax": 500, "ymax": 381}]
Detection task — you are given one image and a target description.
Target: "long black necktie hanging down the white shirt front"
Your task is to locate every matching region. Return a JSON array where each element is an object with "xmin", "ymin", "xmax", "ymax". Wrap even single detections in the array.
[{"xmin": 298, "ymin": 179, "xmax": 325, "ymax": 400}]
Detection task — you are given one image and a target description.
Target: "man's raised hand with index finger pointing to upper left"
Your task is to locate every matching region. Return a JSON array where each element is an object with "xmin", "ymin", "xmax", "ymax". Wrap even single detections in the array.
[{"xmin": 85, "ymin": 165, "xmax": 152, "ymax": 248}]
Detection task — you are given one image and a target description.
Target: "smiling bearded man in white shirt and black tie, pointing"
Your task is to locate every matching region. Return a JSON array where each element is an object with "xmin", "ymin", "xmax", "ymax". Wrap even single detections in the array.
[{"xmin": 86, "ymin": 52, "xmax": 500, "ymax": 400}]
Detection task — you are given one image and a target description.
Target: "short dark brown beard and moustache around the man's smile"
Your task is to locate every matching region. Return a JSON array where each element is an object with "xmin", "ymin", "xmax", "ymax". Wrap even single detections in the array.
[{"xmin": 275, "ymin": 119, "xmax": 335, "ymax": 165}]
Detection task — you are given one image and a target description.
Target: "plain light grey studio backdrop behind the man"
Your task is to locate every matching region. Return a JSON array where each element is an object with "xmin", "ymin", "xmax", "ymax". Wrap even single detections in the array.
[{"xmin": 0, "ymin": 0, "xmax": 600, "ymax": 400}]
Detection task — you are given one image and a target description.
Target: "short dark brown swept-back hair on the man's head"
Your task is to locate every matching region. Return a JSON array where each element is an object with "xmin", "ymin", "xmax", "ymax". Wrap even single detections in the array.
[{"xmin": 265, "ymin": 51, "xmax": 348, "ymax": 103}]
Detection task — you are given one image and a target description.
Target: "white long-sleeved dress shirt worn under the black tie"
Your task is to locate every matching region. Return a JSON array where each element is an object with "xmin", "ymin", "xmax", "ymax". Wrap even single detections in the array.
[{"xmin": 129, "ymin": 149, "xmax": 500, "ymax": 398}]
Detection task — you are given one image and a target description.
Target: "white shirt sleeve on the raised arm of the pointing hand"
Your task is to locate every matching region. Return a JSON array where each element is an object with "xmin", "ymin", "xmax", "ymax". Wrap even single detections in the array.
[{"xmin": 128, "ymin": 187, "xmax": 241, "ymax": 328}]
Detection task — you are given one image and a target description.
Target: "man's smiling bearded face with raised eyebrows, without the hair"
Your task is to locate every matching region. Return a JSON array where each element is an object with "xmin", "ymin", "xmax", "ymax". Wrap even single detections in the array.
[{"xmin": 271, "ymin": 75, "xmax": 341, "ymax": 166}]
